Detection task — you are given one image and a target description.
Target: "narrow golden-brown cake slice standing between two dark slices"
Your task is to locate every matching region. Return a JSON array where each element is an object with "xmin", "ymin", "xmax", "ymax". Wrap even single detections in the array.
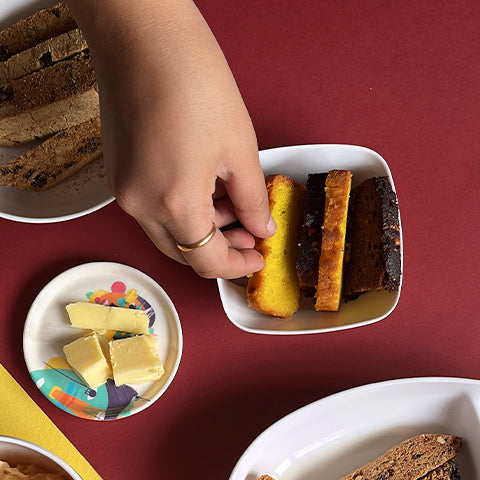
[{"xmin": 315, "ymin": 170, "xmax": 352, "ymax": 312}]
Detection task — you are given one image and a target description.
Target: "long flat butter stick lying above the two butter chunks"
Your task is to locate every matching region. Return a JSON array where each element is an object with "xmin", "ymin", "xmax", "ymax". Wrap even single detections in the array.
[{"xmin": 66, "ymin": 302, "xmax": 149, "ymax": 334}]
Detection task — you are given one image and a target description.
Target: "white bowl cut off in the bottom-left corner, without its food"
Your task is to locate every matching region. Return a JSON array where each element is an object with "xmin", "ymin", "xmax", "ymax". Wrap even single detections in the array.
[{"xmin": 0, "ymin": 435, "xmax": 82, "ymax": 480}]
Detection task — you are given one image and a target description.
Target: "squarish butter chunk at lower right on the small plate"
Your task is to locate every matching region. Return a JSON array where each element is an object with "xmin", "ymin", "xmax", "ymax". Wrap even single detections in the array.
[{"xmin": 109, "ymin": 335, "xmax": 165, "ymax": 386}]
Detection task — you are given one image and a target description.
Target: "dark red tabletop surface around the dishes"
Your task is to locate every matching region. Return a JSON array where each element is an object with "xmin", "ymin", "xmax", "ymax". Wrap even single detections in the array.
[{"xmin": 0, "ymin": 0, "xmax": 480, "ymax": 480}]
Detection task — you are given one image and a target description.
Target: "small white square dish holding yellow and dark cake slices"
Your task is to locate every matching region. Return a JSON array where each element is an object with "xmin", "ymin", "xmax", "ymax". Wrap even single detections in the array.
[{"xmin": 217, "ymin": 145, "xmax": 403, "ymax": 335}]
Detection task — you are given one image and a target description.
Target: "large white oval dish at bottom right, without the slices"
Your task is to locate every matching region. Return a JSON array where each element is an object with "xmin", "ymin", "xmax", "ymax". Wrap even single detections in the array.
[{"xmin": 230, "ymin": 377, "xmax": 480, "ymax": 480}]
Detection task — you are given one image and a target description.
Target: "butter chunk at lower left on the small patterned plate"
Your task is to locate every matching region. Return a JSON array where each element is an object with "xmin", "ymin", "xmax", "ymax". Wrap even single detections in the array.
[{"xmin": 63, "ymin": 332, "xmax": 113, "ymax": 388}]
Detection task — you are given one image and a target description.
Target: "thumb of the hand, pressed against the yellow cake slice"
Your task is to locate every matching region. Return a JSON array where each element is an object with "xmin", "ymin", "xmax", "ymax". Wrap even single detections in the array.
[{"xmin": 225, "ymin": 163, "xmax": 277, "ymax": 238}]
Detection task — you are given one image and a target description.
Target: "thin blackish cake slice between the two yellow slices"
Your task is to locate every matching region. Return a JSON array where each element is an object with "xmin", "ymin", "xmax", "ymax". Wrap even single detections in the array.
[{"xmin": 297, "ymin": 173, "xmax": 327, "ymax": 296}]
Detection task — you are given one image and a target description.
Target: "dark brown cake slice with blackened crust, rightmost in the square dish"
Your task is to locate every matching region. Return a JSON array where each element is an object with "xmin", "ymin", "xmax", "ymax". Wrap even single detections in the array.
[{"xmin": 343, "ymin": 177, "xmax": 401, "ymax": 299}]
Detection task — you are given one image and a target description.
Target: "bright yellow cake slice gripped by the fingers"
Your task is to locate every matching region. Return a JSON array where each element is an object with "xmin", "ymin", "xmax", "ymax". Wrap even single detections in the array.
[{"xmin": 247, "ymin": 175, "xmax": 305, "ymax": 318}]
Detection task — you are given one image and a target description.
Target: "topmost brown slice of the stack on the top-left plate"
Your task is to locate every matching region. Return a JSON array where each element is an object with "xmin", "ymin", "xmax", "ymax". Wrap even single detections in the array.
[{"xmin": 0, "ymin": 3, "xmax": 77, "ymax": 61}]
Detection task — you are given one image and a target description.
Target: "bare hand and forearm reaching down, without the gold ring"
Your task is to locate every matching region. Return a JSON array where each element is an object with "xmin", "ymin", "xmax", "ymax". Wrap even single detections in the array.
[{"xmin": 67, "ymin": 0, "xmax": 276, "ymax": 278}]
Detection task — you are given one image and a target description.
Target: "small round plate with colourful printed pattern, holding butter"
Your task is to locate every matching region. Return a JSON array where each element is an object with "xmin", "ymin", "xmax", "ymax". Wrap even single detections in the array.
[{"xmin": 23, "ymin": 262, "xmax": 183, "ymax": 420}]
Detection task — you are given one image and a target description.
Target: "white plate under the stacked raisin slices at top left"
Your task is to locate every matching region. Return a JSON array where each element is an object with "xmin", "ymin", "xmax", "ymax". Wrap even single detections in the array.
[{"xmin": 0, "ymin": 0, "xmax": 114, "ymax": 223}]
